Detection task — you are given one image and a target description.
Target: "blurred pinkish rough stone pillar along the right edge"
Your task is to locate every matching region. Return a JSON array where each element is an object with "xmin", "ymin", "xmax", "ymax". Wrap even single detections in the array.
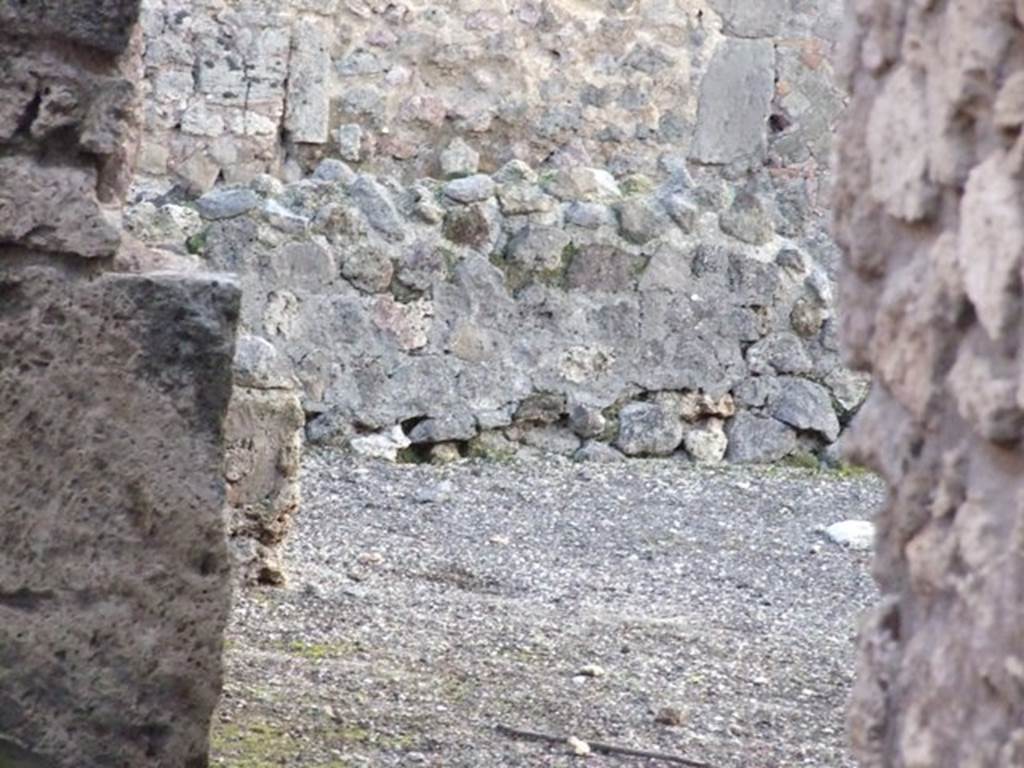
[{"xmin": 836, "ymin": 0, "xmax": 1024, "ymax": 768}]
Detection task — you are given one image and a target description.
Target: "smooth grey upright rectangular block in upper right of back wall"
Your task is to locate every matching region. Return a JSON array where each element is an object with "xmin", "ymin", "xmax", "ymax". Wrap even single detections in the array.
[{"xmin": 690, "ymin": 39, "xmax": 775, "ymax": 163}]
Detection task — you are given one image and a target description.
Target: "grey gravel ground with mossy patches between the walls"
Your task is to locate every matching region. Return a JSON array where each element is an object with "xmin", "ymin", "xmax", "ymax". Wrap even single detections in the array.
[{"xmin": 213, "ymin": 452, "xmax": 883, "ymax": 768}]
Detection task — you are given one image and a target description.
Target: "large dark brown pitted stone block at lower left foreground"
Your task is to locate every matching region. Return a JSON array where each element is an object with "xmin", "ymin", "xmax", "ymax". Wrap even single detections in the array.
[{"xmin": 0, "ymin": 267, "xmax": 239, "ymax": 768}]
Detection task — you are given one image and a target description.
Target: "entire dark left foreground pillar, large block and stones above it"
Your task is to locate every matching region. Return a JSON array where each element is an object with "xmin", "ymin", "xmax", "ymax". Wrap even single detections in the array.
[{"xmin": 0, "ymin": 0, "xmax": 239, "ymax": 768}]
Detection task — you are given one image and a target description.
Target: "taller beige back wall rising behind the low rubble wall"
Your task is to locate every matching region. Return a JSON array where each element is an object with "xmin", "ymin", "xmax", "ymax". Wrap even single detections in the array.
[{"xmin": 141, "ymin": 0, "xmax": 842, "ymax": 191}]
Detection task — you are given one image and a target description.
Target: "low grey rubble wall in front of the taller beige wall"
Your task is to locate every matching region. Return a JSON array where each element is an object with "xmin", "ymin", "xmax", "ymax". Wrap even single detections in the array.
[{"xmin": 129, "ymin": 154, "xmax": 866, "ymax": 461}]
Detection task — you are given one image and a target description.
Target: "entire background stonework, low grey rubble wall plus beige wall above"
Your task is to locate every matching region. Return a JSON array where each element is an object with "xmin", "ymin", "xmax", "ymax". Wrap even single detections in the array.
[{"xmin": 130, "ymin": 0, "xmax": 866, "ymax": 461}]
